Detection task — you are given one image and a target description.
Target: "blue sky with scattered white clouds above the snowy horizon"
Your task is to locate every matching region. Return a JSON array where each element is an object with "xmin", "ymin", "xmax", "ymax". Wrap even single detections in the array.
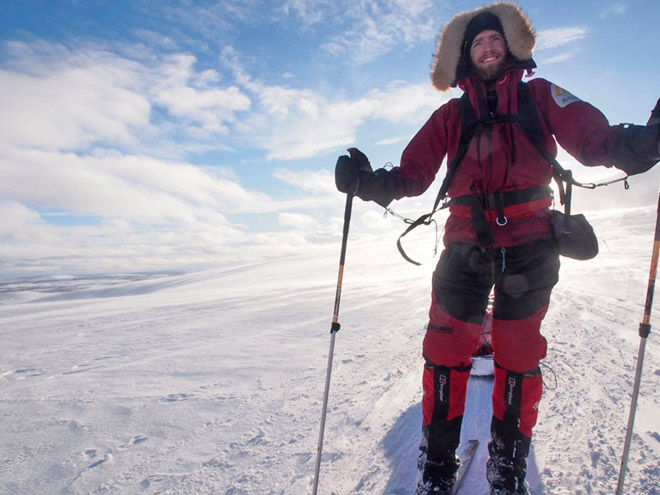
[{"xmin": 0, "ymin": 0, "xmax": 660, "ymax": 278}]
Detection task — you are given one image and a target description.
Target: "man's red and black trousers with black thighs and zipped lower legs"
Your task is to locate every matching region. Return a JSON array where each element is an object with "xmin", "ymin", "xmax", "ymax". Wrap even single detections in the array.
[{"xmin": 422, "ymin": 239, "xmax": 559, "ymax": 464}]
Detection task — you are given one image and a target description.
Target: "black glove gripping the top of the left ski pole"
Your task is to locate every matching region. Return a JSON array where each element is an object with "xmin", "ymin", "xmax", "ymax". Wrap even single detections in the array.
[{"xmin": 335, "ymin": 148, "xmax": 396, "ymax": 206}]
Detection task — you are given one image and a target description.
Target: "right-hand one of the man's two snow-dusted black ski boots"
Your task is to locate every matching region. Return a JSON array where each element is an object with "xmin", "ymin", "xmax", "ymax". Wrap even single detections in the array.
[{"xmin": 486, "ymin": 418, "xmax": 531, "ymax": 495}]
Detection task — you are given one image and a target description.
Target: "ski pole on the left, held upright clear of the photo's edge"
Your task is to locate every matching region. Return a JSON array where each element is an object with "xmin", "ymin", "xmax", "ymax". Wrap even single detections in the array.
[{"xmin": 312, "ymin": 152, "xmax": 355, "ymax": 495}]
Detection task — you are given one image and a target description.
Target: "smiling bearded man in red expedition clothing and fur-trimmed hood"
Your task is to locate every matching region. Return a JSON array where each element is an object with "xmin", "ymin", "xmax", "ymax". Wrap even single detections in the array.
[{"xmin": 336, "ymin": 2, "xmax": 660, "ymax": 495}]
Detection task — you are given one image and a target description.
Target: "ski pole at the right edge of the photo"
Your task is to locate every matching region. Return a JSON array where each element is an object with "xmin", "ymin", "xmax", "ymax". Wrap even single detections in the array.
[{"xmin": 616, "ymin": 191, "xmax": 660, "ymax": 495}]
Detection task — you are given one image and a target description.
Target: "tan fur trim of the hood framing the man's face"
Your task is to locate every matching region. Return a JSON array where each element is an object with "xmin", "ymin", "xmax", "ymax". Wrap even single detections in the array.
[{"xmin": 431, "ymin": 2, "xmax": 536, "ymax": 91}]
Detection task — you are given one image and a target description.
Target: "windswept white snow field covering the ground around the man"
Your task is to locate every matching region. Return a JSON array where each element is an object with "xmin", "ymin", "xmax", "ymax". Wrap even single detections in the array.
[{"xmin": 0, "ymin": 207, "xmax": 660, "ymax": 495}]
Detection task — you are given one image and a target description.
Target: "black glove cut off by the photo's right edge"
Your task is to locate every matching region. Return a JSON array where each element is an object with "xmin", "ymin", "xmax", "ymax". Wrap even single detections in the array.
[{"xmin": 613, "ymin": 99, "xmax": 660, "ymax": 175}]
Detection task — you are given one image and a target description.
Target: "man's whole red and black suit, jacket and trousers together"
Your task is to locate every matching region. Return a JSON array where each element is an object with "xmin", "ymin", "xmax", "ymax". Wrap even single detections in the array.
[{"xmin": 384, "ymin": 69, "xmax": 657, "ymax": 472}]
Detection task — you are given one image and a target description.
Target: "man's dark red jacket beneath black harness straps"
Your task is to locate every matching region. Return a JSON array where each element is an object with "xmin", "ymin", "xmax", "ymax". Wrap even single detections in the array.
[{"xmin": 392, "ymin": 70, "xmax": 624, "ymax": 247}]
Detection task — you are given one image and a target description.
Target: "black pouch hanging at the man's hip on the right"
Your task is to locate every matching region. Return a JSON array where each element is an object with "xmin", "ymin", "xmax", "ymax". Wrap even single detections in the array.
[{"xmin": 551, "ymin": 210, "xmax": 598, "ymax": 260}]
